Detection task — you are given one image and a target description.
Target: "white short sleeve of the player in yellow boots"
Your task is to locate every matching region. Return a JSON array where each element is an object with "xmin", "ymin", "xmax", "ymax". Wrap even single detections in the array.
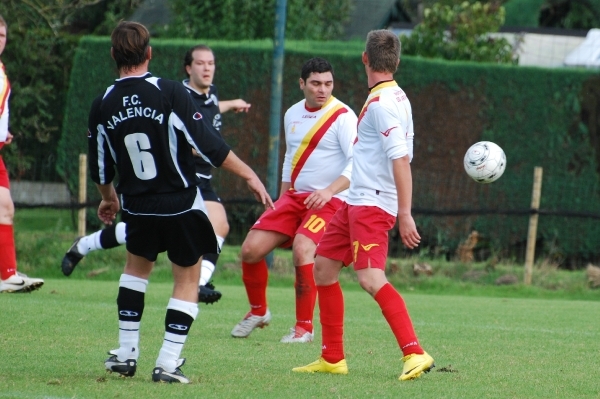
[{"xmin": 373, "ymin": 102, "xmax": 410, "ymax": 159}]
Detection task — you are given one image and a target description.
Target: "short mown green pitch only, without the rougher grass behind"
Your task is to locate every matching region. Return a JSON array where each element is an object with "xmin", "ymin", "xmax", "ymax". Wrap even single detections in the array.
[{"xmin": 0, "ymin": 279, "xmax": 600, "ymax": 398}]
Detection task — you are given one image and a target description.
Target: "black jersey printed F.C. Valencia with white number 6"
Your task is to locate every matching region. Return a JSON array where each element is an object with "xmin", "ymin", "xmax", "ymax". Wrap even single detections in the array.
[{"xmin": 88, "ymin": 73, "xmax": 230, "ymax": 213}]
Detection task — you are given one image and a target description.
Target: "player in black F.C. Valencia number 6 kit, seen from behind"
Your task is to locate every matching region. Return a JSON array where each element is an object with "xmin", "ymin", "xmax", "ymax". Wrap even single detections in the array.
[{"xmin": 88, "ymin": 21, "xmax": 273, "ymax": 383}]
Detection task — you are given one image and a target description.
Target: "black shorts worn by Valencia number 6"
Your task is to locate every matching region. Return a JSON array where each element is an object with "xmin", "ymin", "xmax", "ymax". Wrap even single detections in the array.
[{"xmin": 122, "ymin": 209, "xmax": 219, "ymax": 267}]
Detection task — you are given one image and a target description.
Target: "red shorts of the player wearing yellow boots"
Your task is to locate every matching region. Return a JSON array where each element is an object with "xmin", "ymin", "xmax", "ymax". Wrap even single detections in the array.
[{"xmin": 317, "ymin": 204, "xmax": 396, "ymax": 270}]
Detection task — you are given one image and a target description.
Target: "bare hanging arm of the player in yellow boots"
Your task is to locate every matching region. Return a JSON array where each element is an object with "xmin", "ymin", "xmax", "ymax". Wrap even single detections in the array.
[{"xmin": 392, "ymin": 155, "xmax": 421, "ymax": 249}]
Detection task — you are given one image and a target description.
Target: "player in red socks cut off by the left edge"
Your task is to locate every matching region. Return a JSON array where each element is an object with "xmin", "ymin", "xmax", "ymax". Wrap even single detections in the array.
[{"xmin": 0, "ymin": 15, "xmax": 44, "ymax": 293}]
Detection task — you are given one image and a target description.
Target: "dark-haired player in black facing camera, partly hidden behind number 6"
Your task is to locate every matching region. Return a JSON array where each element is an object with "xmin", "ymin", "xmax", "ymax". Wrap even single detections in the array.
[{"xmin": 61, "ymin": 45, "xmax": 250, "ymax": 304}]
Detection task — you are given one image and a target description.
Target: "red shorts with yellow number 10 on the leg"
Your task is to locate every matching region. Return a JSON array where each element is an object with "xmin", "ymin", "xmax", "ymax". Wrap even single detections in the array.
[{"xmin": 250, "ymin": 191, "xmax": 344, "ymax": 248}]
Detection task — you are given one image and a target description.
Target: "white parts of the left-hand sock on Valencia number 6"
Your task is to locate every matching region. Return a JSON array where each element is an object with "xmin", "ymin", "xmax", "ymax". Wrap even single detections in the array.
[{"xmin": 117, "ymin": 274, "xmax": 148, "ymax": 362}]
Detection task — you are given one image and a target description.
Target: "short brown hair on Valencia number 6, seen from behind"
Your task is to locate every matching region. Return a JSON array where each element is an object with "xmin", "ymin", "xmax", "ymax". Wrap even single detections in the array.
[{"xmin": 110, "ymin": 21, "xmax": 150, "ymax": 72}]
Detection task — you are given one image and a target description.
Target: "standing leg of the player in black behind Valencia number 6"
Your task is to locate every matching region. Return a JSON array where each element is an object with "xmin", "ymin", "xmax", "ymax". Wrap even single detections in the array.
[{"xmin": 198, "ymin": 200, "xmax": 229, "ymax": 304}]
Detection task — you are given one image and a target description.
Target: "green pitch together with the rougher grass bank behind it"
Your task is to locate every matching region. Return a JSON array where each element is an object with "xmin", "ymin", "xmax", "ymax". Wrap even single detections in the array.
[{"xmin": 0, "ymin": 210, "xmax": 600, "ymax": 398}]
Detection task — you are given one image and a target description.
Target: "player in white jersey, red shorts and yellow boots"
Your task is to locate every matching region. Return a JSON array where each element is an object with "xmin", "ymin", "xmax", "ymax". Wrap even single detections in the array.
[{"xmin": 293, "ymin": 30, "xmax": 434, "ymax": 380}]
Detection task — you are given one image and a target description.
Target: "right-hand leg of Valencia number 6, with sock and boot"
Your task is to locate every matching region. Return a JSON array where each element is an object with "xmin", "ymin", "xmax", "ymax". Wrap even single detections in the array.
[{"xmin": 152, "ymin": 258, "xmax": 202, "ymax": 384}]
